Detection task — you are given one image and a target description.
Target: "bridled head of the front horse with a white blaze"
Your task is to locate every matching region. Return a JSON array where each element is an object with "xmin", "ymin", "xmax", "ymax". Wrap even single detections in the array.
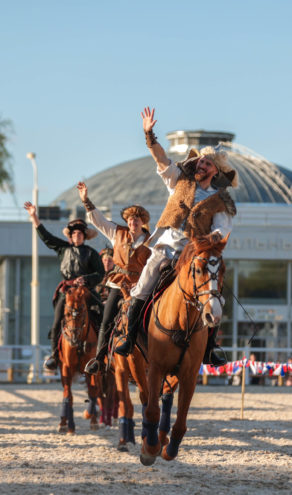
[{"xmin": 191, "ymin": 236, "xmax": 228, "ymax": 327}]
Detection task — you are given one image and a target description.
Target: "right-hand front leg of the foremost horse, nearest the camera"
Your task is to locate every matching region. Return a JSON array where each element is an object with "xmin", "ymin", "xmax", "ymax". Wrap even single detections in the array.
[{"xmin": 161, "ymin": 369, "xmax": 198, "ymax": 461}]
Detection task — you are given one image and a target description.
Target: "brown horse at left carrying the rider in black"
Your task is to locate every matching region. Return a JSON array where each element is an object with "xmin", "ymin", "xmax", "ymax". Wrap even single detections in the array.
[{"xmin": 59, "ymin": 286, "xmax": 101, "ymax": 433}]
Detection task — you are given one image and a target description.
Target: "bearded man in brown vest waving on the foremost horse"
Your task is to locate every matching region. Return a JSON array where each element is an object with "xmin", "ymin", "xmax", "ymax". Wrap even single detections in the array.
[{"xmin": 115, "ymin": 107, "xmax": 237, "ymax": 366}]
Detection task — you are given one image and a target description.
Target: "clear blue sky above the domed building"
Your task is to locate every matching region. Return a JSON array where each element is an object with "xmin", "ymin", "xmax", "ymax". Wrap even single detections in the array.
[{"xmin": 0, "ymin": 0, "xmax": 292, "ymax": 211}]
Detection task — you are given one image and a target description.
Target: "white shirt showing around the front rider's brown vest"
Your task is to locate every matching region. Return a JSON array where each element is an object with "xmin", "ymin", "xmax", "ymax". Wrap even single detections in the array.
[{"xmin": 148, "ymin": 162, "xmax": 232, "ymax": 258}]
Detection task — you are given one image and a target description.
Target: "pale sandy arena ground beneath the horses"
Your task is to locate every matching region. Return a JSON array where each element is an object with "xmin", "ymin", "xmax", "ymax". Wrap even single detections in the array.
[{"xmin": 0, "ymin": 383, "xmax": 292, "ymax": 495}]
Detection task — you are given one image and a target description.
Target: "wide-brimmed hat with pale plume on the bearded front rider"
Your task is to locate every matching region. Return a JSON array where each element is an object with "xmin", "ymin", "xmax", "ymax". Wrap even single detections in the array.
[{"xmin": 178, "ymin": 146, "xmax": 238, "ymax": 187}]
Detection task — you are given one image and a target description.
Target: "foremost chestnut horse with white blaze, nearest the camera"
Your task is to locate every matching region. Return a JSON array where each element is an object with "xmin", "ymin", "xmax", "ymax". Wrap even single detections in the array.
[{"xmin": 140, "ymin": 238, "xmax": 227, "ymax": 466}]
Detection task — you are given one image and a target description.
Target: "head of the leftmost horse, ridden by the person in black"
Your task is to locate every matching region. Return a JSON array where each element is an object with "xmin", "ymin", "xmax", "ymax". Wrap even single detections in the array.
[{"xmin": 62, "ymin": 287, "xmax": 89, "ymax": 347}]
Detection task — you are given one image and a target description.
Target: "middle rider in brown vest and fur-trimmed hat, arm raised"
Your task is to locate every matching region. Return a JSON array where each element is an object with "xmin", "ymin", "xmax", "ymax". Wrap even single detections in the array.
[{"xmin": 77, "ymin": 182, "xmax": 151, "ymax": 374}]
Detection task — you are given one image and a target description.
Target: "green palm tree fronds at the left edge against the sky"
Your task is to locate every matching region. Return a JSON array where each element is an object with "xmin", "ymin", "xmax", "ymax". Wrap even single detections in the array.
[{"xmin": 0, "ymin": 117, "xmax": 14, "ymax": 192}]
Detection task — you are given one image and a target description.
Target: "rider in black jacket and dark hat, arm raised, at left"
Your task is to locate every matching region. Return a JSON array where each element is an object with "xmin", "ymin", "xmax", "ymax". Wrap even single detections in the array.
[{"xmin": 24, "ymin": 201, "xmax": 104, "ymax": 370}]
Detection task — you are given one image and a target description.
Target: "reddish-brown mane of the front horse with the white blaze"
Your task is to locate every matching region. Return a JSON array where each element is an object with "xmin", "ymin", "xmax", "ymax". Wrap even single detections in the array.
[{"xmin": 175, "ymin": 236, "xmax": 229, "ymax": 274}]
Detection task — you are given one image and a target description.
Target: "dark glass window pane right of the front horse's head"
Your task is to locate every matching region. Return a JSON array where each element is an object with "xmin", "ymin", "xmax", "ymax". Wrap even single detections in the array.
[{"xmin": 238, "ymin": 260, "xmax": 287, "ymax": 304}]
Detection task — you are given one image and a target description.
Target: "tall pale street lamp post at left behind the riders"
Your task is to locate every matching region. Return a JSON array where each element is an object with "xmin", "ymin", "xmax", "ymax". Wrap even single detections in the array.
[{"xmin": 26, "ymin": 152, "xmax": 40, "ymax": 382}]
